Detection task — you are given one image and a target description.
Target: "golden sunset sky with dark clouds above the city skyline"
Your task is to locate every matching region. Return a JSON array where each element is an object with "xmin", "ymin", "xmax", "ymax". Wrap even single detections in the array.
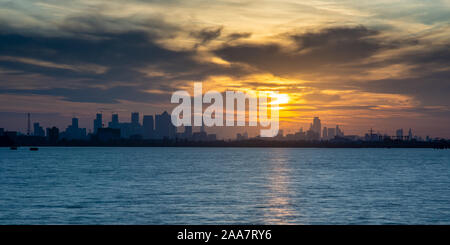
[{"xmin": 0, "ymin": 0, "xmax": 450, "ymax": 138}]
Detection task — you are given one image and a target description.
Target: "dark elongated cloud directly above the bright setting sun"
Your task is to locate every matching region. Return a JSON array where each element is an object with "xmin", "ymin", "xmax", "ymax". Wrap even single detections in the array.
[{"xmin": 215, "ymin": 27, "xmax": 382, "ymax": 76}]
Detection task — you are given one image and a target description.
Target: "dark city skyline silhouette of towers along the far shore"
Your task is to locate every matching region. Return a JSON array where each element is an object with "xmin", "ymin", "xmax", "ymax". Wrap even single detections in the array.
[{"xmin": 0, "ymin": 111, "xmax": 445, "ymax": 144}]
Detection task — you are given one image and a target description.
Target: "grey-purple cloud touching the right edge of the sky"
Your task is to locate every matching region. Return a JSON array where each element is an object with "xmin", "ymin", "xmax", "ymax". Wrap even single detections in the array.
[{"xmin": 346, "ymin": 41, "xmax": 450, "ymax": 106}]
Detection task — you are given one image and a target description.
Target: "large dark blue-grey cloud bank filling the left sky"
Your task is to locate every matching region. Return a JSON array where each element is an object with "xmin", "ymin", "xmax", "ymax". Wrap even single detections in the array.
[{"xmin": 0, "ymin": 17, "xmax": 250, "ymax": 103}]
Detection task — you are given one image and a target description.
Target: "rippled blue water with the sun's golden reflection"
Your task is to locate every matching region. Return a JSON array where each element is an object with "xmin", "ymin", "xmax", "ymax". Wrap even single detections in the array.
[{"xmin": 0, "ymin": 147, "xmax": 450, "ymax": 224}]
